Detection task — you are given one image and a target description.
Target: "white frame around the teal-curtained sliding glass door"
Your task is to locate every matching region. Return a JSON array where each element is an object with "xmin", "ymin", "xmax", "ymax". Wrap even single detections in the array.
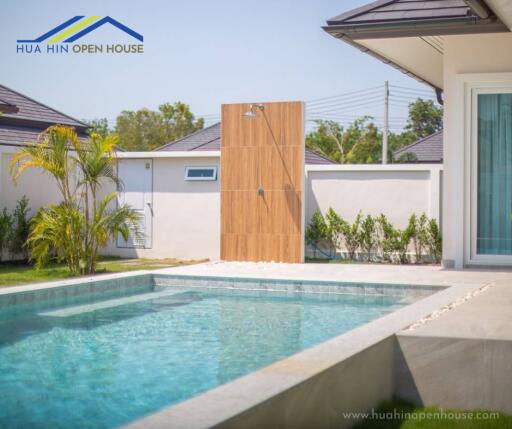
[{"xmin": 466, "ymin": 79, "xmax": 512, "ymax": 265}]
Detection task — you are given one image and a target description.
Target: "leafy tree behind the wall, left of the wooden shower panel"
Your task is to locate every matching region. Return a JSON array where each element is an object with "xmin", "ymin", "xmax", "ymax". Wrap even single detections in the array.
[{"xmin": 115, "ymin": 101, "xmax": 204, "ymax": 151}]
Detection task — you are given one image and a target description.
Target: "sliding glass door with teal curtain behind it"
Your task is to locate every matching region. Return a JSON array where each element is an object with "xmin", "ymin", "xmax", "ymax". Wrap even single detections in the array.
[{"xmin": 471, "ymin": 89, "xmax": 512, "ymax": 263}]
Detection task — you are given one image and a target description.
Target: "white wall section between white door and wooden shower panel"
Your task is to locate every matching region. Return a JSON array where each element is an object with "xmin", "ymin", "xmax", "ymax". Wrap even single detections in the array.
[{"xmin": 104, "ymin": 157, "xmax": 220, "ymax": 260}]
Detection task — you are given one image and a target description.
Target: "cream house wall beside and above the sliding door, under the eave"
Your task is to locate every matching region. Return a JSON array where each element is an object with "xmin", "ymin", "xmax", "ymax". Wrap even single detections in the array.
[{"xmin": 443, "ymin": 33, "xmax": 512, "ymax": 268}]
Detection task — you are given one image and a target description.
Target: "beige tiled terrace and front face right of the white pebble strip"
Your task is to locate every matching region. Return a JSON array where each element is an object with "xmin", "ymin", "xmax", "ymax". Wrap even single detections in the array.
[{"xmin": 395, "ymin": 280, "xmax": 512, "ymax": 413}]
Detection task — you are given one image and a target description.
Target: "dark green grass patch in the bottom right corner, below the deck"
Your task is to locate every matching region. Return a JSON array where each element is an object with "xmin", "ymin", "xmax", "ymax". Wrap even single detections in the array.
[{"xmin": 355, "ymin": 401, "xmax": 512, "ymax": 429}]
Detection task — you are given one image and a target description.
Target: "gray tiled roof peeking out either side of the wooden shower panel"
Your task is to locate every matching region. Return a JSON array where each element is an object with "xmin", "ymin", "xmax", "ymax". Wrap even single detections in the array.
[{"xmin": 155, "ymin": 122, "xmax": 334, "ymax": 165}]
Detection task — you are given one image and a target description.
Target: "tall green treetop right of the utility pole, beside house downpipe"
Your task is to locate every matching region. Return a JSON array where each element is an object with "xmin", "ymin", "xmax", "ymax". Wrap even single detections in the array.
[{"xmin": 405, "ymin": 98, "xmax": 443, "ymax": 140}]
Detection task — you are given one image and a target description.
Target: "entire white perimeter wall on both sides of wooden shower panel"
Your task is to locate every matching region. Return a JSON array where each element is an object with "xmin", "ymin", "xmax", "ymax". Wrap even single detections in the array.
[{"xmin": 0, "ymin": 146, "xmax": 443, "ymax": 260}]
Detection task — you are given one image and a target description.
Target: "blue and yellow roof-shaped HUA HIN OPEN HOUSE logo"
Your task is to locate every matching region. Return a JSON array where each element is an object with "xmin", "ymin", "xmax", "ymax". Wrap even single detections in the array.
[{"xmin": 16, "ymin": 16, "xmax": 144, "ymax": 54}]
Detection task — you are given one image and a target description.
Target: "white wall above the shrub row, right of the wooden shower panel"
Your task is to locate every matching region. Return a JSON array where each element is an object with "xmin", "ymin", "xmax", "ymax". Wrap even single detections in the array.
[{"xmin": 305, "ymin": 164, "xmax": 443, "ymax": 228}]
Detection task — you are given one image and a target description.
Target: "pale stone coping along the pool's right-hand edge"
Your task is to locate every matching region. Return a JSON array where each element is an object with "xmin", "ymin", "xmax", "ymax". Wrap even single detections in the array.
[{"xmin": 122, "ymin": 272, "xmax": 487, "ymax": 429}]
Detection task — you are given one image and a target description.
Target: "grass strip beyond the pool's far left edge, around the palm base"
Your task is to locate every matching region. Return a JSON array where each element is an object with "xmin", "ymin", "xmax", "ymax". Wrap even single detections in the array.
[{"xmin": 0, "ymin": 257, "xmax": 205, "ymax": 287}]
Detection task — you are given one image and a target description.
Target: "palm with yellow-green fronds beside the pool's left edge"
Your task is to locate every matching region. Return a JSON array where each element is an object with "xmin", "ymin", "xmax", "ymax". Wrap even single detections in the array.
[{"xmin": 10, "ymin": 126, "xmax": 139, "ymax": 274}]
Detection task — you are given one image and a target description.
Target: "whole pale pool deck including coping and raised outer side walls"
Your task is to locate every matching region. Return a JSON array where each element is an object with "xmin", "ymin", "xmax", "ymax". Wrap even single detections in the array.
[{"xmin": 122, "ymin": 263, "xmax": 512, "ymax": 429}]
